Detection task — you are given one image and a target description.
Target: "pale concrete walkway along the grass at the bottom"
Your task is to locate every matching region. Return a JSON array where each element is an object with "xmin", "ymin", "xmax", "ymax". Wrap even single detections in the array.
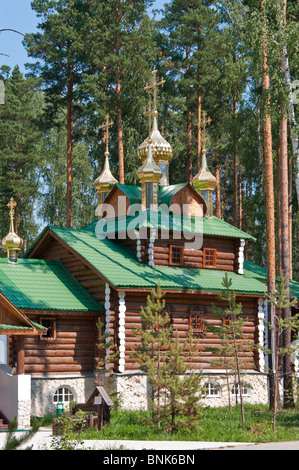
[{"xmin": 0, "ymin": 428, "xmax": 299, "ymax": 452}]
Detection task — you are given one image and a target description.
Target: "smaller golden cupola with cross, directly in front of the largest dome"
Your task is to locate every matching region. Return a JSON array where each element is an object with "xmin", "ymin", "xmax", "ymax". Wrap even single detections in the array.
[{"xmin": 137, "ymin": 103, "xmax": 162, "ymax": 210}]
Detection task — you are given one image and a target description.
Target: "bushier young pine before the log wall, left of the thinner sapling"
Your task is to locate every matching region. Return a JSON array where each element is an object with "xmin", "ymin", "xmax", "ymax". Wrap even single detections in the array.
[{"xmin": 133, "ymin": 285, "xmax": 202, "ymax": 432}]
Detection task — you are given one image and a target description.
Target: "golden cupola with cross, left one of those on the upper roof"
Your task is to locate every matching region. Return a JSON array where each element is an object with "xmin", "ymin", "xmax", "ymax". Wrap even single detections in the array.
[{"xmin": 94, "ymin": 115, "xmax": 118, "ymax": 215}]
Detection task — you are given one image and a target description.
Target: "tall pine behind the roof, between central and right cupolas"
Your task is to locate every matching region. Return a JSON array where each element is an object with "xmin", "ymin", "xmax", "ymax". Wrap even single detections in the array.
[{"xmin": 160, "ymin": 0, "xmax": 219, "ymax": 182}]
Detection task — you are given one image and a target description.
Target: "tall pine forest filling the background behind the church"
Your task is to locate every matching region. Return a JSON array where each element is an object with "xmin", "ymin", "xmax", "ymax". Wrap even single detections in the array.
[{"xmin": 0, "ymin": 0, "xmax": 299, "ymax": 281}]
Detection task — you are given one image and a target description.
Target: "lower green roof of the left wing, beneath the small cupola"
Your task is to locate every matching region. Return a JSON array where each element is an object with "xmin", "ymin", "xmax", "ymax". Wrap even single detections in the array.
[{"xmin": 0, "ymin": 258, "xmax": 103, "ymax": 312}]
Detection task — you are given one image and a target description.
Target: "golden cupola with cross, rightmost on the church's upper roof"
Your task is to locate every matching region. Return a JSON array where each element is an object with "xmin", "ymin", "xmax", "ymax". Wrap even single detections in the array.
[{"xmin": 192, "ymin": 113, "xmax": 217, "ymax": 217}]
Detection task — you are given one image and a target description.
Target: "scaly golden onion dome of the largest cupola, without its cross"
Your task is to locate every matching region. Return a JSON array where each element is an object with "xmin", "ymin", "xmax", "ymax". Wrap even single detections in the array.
[{"xmin": 138, "ymin": 114, "xmax": 173, "ymax": 162}]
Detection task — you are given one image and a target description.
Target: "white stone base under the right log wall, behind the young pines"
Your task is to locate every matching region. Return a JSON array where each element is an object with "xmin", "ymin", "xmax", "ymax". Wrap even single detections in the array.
[{"xmin": 114, "ymin": 371, "xmax": 268, "ymax": 410}]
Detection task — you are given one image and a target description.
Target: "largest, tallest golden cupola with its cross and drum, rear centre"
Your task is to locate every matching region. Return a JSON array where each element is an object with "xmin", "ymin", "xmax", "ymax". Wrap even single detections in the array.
[{"xmin": 138, "ymin": 69, "xmax": 173, "ymax": 186}]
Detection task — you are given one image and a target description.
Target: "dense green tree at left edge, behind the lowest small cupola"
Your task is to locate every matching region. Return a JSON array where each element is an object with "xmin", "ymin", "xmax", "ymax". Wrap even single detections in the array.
[{"xmin": 0, "ymin": 66, "xmax": 42, "ymax": 248}]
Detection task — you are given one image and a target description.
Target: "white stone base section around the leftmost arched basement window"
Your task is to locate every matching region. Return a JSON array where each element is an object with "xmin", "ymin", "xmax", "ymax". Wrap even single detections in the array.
[{"xmin": 31, "ymin": 376, "xmax": 95, "ymax": 416}]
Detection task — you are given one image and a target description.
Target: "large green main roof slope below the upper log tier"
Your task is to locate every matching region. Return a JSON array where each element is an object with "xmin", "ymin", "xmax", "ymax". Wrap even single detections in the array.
[{"xmin": 38, "ymin": 226, "xmax": 266, "ymax": 295}]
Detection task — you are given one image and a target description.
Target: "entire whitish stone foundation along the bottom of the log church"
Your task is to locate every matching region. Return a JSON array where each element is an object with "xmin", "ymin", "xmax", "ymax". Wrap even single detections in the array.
[{"xmin": 31, "ymin": 371, "xmax": 268, "ymax": 416}]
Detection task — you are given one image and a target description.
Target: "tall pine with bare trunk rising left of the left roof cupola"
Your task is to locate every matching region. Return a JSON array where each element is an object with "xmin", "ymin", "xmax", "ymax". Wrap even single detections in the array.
[{"xmin": 24, "ymin": 0, "xmax": 88, "ymax": 228}]
